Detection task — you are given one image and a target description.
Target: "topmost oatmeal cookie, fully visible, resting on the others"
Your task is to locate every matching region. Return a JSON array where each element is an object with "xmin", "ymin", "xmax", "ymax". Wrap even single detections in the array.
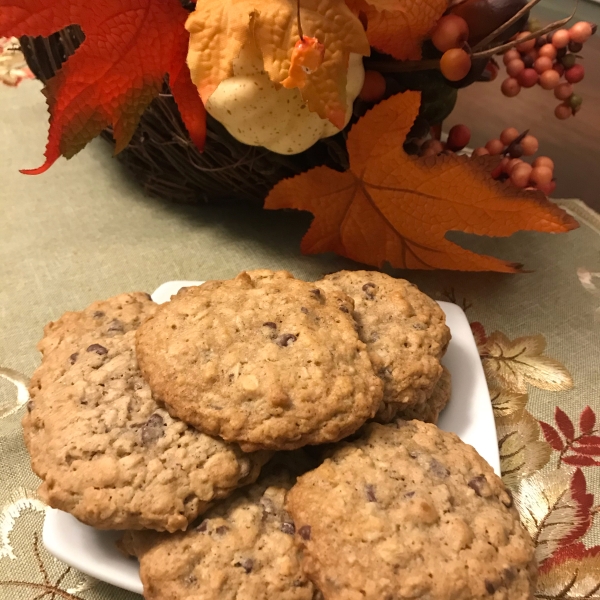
[{"xmin": 137, "ymin": 273, "xmax": 382, "ymax": 451}]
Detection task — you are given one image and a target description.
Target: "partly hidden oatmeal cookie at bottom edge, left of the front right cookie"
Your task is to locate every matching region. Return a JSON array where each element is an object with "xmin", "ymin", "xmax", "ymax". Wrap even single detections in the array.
[{"xmin": 122, "ymin": 473, "xmax": 317, "ymax": 600}]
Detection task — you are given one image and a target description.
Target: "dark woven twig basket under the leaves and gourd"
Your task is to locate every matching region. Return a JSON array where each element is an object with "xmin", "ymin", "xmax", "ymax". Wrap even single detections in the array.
[{"xmin": 21, "ymin": 26, "xmax": 348, "ymax": 204}]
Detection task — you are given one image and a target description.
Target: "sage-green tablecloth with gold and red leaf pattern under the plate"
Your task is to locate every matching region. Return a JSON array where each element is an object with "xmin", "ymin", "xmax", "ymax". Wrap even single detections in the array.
[{"xmin": 0, "ymin": 82, "xmax": 600, "ymax": 600}]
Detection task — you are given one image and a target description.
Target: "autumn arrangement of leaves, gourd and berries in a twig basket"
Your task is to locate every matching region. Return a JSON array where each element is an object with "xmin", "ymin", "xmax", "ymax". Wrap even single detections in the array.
[{"xmin": 0, "ymin": 0, "xmax": 596, "ymax": 272}]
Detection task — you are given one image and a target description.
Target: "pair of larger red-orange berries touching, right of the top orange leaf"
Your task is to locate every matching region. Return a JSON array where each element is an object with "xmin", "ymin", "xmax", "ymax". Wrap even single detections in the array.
[{"xmin": 431, "ymin": 14, "xmax": 472, "ymax": 81}]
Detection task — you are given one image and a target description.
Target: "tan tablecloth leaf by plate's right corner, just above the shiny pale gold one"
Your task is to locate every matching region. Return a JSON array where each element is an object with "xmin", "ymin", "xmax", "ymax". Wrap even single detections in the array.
[{"xmin": 496, "ymin": 410, "xmax": 552, "ymax": 487}]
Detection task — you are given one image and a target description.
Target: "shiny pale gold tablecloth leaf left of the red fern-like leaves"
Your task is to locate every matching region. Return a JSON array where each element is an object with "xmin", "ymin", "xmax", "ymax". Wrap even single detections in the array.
[{"xmin": 514, "ymin": 469, "xmax": 589, "ymax": 563}]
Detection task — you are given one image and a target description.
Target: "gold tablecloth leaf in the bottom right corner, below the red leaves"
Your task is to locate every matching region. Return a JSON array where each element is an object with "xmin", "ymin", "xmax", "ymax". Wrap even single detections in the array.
[{"xmin": 536, "ymin": 544, "xmax": 600, "ymax": 600}]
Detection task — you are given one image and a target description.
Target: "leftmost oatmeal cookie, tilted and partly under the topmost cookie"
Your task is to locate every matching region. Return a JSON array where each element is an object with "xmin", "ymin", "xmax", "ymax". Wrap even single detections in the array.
[{"xmin": 23, "ymin": 295, "xmax": 268, "ymax": 531}]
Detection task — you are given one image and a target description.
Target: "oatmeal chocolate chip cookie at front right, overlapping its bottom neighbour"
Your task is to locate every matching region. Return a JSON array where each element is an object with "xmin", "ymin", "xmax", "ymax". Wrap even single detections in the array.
[{"xmin": 286, "ymin": 420, "xmax": 537, "ymax": 600}]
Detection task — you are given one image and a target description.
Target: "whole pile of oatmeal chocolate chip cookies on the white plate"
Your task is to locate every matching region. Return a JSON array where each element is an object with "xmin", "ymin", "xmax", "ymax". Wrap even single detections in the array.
[{"xmin": 23, "ymin": 270, "xmax": 536, "ymax": 600}]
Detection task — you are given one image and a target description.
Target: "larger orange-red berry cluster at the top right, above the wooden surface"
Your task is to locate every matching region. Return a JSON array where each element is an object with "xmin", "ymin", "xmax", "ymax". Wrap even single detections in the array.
[{"xmin": 502, "ymin": 21, "xmax": 597, "ymax": 120}]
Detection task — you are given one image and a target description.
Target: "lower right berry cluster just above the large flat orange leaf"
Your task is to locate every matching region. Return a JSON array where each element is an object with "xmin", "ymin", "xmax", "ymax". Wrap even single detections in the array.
[{"xmin": 473, "ymin": 127, "xmax": 556, "ymax": 195}]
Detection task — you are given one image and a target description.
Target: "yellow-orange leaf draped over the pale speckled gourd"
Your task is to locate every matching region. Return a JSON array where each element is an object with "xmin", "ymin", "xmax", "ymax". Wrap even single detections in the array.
[{"xmin": 186, "ymin": 0, "xmax": 370, "ymax": 129}]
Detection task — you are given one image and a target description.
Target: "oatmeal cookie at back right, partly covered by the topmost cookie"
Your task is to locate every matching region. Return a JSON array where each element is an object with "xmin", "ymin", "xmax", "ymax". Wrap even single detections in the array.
[{"xmin": 315, "ymin": 271, "xmax": 450, "ymax": 407}]
